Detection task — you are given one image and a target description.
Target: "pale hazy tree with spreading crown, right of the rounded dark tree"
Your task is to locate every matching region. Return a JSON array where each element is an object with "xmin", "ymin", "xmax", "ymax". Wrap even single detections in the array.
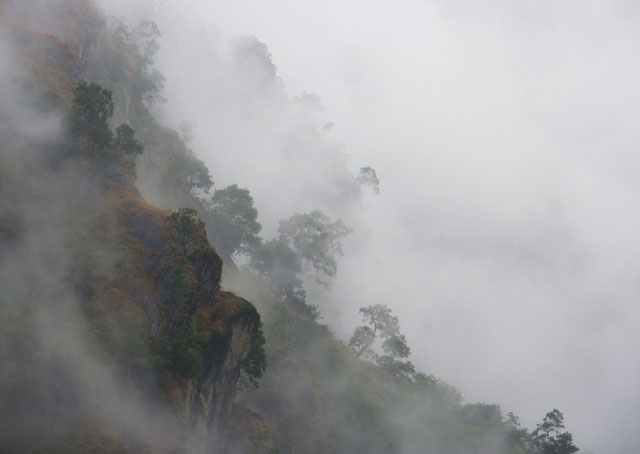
[{"xmin": 278, "ymin": 210, "xmax": 351, "ymax": 285}]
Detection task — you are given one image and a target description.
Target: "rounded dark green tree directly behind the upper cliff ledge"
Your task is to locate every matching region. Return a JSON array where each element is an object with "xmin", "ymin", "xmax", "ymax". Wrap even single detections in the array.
[{"xmin": 206, "ymin": 184, "xmax": 262, "ymax": 257}]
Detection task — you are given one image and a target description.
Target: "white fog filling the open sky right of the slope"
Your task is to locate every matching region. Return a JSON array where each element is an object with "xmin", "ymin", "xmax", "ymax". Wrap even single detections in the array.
[{"xmin": 97, "ymin": 0, "xmax": 640, "ymax": 453}]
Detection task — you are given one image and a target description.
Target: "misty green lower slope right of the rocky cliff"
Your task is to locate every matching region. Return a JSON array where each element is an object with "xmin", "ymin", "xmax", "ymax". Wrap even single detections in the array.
[{"xmin": 224, "ymin": 270, "xmax": 535, "ymax": 454}]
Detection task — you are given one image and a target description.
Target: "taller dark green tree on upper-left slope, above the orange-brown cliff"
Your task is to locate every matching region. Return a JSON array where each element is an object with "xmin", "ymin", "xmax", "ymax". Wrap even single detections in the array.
[{"xmin": 71, "ymin": 81, "xmax": 113, "ymax": 149}]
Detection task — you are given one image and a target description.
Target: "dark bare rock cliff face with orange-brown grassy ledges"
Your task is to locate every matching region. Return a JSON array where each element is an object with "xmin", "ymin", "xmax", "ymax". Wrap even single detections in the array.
[{"xmin": 112, "ymin": 185, "xmax": 260, "ymax": 454}]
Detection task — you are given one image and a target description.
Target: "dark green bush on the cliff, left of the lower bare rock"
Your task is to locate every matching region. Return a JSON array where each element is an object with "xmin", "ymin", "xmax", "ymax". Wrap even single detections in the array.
[{"xmin": 151, "ymin": 325, "xmax": 204, "ymax": 379}]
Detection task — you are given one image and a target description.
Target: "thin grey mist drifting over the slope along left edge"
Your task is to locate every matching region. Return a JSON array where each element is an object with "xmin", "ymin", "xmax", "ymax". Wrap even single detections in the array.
[{"xmin": 0, "ymin": 14, "xmax": 188, "ymax": 452}]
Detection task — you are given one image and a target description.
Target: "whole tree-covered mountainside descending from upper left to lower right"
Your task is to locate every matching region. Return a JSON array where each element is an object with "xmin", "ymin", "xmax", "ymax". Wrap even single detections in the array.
[{"xmin": 0, "ymin": 0, "xmax": 578, "ymax": 454}]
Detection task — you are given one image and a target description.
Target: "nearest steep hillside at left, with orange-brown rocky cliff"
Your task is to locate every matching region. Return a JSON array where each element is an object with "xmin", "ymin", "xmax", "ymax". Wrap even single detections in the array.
[{"xmin": 0, "ymin": 2, "xmax": 260, "ymax": 453}]
